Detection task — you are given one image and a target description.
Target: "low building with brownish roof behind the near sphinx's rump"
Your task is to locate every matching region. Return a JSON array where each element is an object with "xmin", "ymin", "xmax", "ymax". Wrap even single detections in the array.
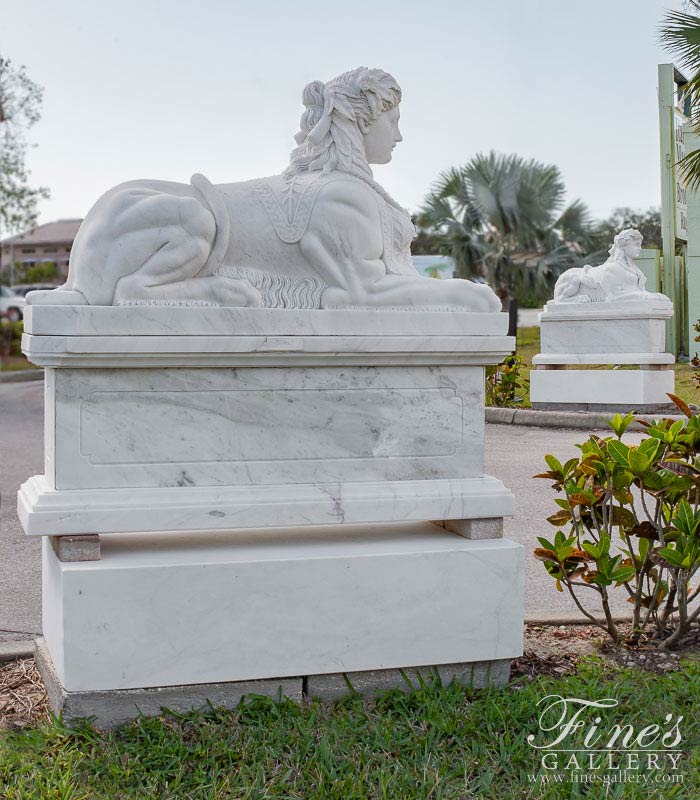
[{"xmin": 0, "ymin": 219, "xmax": 82, "ymax": 278}]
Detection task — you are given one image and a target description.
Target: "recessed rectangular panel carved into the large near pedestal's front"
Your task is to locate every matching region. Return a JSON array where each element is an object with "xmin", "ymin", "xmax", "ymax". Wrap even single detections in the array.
[{"xmin": 80, "ymin": 387, "xmax": 462, "ymax": 464}]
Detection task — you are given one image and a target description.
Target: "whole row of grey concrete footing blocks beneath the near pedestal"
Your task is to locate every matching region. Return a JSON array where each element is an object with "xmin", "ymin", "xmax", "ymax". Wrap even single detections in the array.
[{"xmin": 35, "ymin": 637, "xmax": 510, "ymax": 730}]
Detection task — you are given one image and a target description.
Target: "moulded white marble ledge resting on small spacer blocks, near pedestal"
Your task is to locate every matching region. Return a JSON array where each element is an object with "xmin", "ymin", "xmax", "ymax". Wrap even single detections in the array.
[{"xmin": 17, "ymin": 475, "xmax": 514, "ymax": 536}]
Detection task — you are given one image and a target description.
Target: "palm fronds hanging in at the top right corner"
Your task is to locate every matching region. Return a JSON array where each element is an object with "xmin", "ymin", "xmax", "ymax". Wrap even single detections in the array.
[{"xmin": 660, "ymin": 0, "xmax": 700, "ymax": 189}]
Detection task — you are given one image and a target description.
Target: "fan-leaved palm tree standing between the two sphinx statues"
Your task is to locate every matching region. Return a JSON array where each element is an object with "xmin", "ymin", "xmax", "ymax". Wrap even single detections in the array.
[{"xmin": 417, "ymin": 152, "xmax": 601, "ymax": 316}]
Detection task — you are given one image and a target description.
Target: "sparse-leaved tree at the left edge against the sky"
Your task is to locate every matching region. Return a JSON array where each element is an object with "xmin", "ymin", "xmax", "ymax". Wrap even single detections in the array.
[{"xmin": 0, "ymin": 56, "xmax": 49, "ymax": 268}]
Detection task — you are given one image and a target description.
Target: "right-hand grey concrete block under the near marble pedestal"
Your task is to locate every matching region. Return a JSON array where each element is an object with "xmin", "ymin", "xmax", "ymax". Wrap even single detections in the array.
[{"xmin": 304, "ymin": 659, "xmax": 510, "ymax": 700}]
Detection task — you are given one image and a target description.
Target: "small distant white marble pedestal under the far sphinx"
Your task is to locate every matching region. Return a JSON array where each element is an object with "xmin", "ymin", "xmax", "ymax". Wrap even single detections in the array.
[{"xmin": 530, "ymin": 302, "xmax": 675, "ymax": 413}]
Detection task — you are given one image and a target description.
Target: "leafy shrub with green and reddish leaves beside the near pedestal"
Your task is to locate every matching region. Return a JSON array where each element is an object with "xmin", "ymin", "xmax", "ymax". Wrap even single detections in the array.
[{"xmin": 534, "ymin": 395, "xmax": 700, "ymax": 648}]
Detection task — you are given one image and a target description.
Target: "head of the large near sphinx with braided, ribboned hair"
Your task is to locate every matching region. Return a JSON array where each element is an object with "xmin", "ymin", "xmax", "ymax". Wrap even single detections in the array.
[{"xmin": 285, "ymin": 67, "xmax": 401, "ymax": 177}]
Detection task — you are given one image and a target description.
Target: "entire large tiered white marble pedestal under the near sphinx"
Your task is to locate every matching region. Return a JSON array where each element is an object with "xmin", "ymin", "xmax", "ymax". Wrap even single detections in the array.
[{"xmin": 18, "ymin": 306, "xmax": 523, "ymax": 710}]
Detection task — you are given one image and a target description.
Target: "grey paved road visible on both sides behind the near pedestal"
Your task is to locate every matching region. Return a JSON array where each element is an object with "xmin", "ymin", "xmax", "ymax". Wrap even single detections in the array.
[{"xmin": 0, "ymin": 381, "xmax": 639, "ymax": 641}]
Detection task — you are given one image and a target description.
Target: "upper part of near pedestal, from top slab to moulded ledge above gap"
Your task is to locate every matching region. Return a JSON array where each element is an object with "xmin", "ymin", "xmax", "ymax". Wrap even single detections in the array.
[{"xmin": 20, "ymin": 306, "xmax": 513, "ymax": 534}]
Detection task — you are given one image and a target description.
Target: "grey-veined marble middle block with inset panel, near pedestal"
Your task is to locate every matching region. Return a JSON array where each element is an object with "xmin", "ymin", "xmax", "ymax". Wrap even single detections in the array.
[{"xmin": 46, "ymin": 366, "xmax": 484, "ymax": 489}]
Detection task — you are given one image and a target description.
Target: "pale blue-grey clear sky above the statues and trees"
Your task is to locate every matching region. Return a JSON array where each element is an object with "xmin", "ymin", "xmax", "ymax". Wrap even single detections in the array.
[{"xmin": 0, "ymin": 0, "xmax": 682, "ymax": 228}]
